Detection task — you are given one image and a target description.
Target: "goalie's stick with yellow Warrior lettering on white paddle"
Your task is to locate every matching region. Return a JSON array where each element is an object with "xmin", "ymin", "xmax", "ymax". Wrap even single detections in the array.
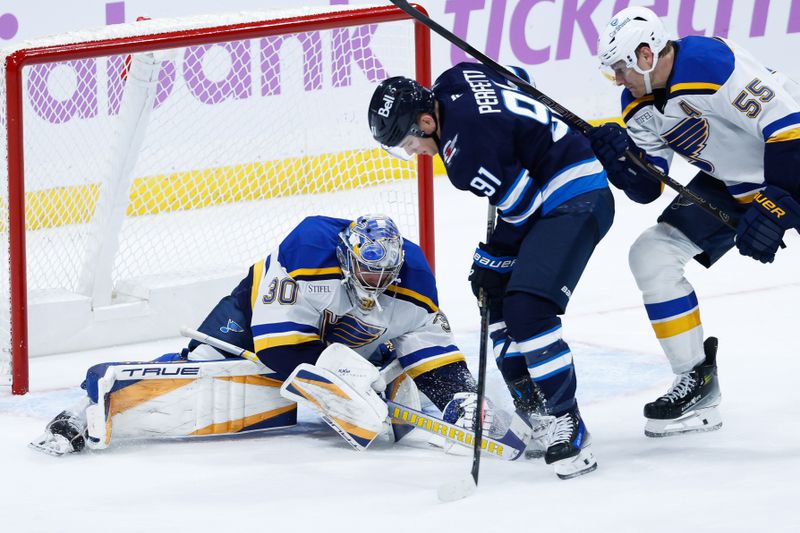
[{"xmin": 180, "ymin": 327, "xmax": 528, "ymax": 461}]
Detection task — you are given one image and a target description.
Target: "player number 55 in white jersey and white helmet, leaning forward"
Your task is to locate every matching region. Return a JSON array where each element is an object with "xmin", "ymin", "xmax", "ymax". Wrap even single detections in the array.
[{"xmin": 589, "ymin": 7, "xmax": 800, "ymax": 436}]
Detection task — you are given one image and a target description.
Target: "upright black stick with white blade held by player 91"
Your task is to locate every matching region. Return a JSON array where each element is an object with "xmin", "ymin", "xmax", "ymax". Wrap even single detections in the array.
[{"xmin": 438, "ymin": 204, "xmax": 497, "ymax": 502}]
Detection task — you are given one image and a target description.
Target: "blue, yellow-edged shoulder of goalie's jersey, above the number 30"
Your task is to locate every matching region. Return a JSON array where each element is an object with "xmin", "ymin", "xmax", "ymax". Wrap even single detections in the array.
[{"xmin": 278, "ymin": 216, "xmax": 350, "ymax": 281}]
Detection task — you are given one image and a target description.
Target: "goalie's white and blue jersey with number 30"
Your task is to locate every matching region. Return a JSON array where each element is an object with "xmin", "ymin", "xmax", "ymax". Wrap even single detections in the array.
[{"xmin": 251, "ymin": 217, "xmax": 464, "ymax": 378}]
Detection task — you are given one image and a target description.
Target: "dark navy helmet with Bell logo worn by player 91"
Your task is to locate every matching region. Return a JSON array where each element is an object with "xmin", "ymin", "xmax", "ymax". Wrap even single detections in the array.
[{"xmin": 368, "ymin": 76, "xmax": 439, "ymax": 161}]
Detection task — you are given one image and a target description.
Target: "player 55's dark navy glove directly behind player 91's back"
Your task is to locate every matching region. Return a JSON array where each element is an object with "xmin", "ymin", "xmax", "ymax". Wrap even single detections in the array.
[{"xmin": 586, "ymin": 122, "xmax": 661, "ymax": 204}]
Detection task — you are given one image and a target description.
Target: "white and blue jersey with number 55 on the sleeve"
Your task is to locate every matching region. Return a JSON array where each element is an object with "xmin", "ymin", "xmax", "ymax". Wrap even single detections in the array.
[{"xmin": 622, "ymin": 37, "xmax": 800, "ymax": 203}]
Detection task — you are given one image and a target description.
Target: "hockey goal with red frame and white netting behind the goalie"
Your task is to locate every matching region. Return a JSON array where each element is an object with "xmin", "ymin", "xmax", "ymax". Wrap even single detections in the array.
[{"xmin": 0, "ymin": 6, "xmax": 433, "ymax": 393}]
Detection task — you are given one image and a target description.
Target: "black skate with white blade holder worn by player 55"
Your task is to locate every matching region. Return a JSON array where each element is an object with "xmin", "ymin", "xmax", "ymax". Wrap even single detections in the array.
[{"xmin": 644, "ymin": 337, "xmax": 722, "ymax": 437}]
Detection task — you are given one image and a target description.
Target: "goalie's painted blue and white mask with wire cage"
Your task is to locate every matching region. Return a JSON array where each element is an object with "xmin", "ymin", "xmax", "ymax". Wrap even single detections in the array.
[{"xmin": 336, "ymin": 215, "xmax": 403, "ymax": 311}]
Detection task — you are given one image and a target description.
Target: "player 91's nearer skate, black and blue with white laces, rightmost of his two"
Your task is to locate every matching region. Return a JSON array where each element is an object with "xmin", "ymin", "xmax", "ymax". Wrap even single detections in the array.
[{"xmin": 544, "ymin": 407, "xmax": 597, "ymax": 479}]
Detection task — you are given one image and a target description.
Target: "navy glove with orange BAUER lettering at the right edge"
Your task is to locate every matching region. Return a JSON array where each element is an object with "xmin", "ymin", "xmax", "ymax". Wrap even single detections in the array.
[{"xmin": 736, "ymin": 185, "xmax": 800, "ymax": 263}]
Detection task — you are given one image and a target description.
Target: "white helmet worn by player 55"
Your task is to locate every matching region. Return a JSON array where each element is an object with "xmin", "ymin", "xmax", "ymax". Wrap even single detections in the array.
[{"xmin": 597, "ymin": 7, "xmax": 669, "ymax": 74}]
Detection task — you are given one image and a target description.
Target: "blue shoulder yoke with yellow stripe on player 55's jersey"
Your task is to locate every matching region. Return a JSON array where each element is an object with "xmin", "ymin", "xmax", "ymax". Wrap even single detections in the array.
[{"xmin": 669, "ymin": 36, "xmax": 736, "ymax": 98}]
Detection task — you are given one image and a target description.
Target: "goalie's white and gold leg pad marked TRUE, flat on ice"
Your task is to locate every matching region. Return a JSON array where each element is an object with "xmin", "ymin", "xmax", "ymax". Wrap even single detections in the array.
[{"xmin": 86, "ymin": 359, "xmax": 297, "ymax": 449}]
